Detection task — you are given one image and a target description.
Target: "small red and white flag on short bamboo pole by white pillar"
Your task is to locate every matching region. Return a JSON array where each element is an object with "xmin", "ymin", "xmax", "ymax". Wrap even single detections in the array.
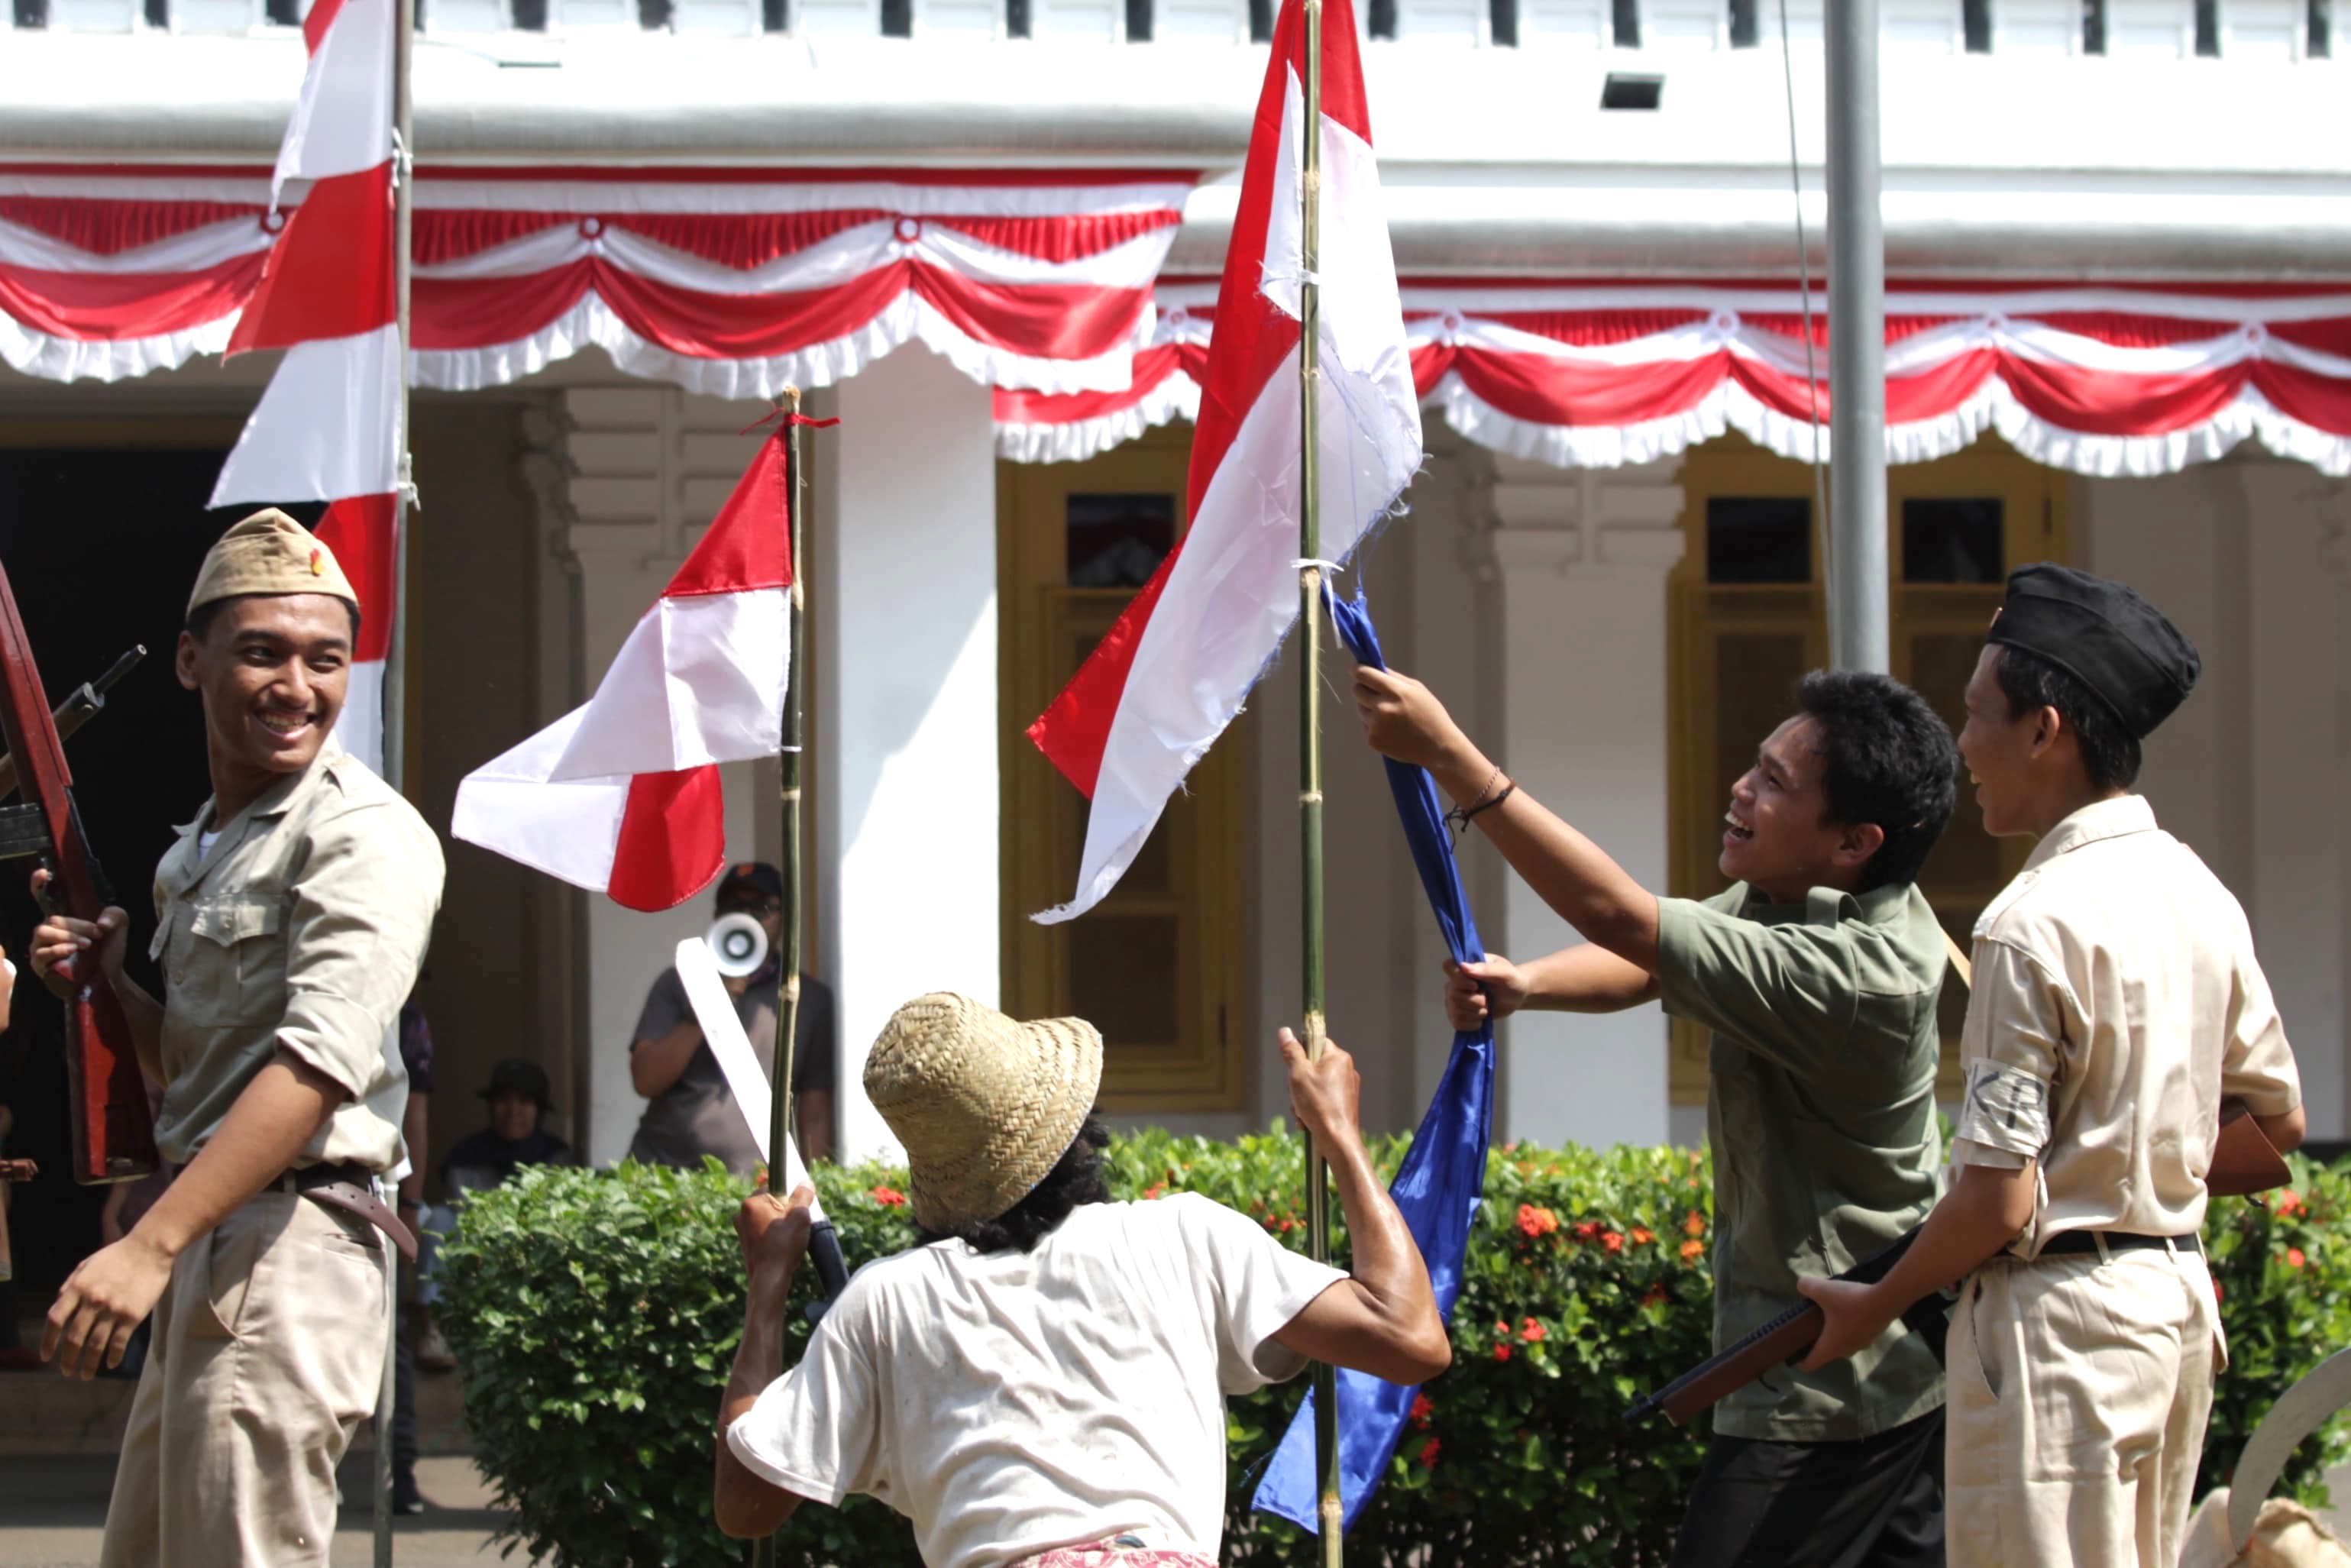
[{"xmin": 449, "ymin": 435, "xmax": 792, "ymax": 910}]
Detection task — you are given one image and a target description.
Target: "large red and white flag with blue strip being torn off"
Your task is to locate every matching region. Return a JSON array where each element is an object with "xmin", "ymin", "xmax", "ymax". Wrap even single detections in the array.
[{"xmin": 1027, "ymin": 0, "xmax": 1420, "ymax": 924}]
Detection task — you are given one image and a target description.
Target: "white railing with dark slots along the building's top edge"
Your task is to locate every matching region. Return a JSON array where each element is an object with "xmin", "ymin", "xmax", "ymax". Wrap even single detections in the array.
[{"xmin": 14, "ymin": 0, "xmax": 2351, "ymax": 61}]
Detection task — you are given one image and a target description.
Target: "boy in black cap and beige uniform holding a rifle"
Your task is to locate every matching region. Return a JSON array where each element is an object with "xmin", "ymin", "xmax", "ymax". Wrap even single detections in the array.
[{"xmin": 1801, "ymin": 564, "xmax": 2304, "ymax": 1568}]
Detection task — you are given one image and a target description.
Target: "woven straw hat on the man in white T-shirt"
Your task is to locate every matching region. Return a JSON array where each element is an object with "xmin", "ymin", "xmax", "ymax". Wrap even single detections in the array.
[{"xmin": 865, "ymin": 992, "xmax": 1103, "ymax": 1232}]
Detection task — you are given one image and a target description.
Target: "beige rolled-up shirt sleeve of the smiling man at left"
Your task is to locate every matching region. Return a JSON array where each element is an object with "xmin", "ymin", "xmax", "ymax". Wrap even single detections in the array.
[{"xmin": 277, "ymin": 804, "xmax": 442, "ymax": 1098}]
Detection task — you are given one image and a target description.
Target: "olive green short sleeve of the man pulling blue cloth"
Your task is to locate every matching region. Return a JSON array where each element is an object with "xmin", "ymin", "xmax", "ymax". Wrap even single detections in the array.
[{"xmin": 1657, "ymin": 884, "xmax": 1860, "ymax": 1077}]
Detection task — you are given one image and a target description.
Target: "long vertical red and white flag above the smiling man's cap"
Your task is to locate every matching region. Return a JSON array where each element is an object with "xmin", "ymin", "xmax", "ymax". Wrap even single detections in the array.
[{"xmin": 212, "ymin": 0, "xmax": 402, "ymax": 768}]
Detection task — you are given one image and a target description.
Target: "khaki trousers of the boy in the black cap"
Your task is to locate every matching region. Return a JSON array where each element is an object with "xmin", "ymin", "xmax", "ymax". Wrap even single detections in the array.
[{"xmin": 1945, "ymin": 1248, "xmax": 2226, "ymax": 1568}]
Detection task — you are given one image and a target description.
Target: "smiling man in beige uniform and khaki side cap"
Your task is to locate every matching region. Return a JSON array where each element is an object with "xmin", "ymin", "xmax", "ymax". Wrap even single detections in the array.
[{"xmin": 33, "ymin": 512, "xmax": 442, "ymax": 1568}]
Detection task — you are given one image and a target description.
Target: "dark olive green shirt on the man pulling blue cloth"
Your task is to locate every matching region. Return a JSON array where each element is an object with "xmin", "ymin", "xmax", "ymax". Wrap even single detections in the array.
[{"xmin": 1657, "ymin": 884, "xmax": 1949, "ymax": 1444}]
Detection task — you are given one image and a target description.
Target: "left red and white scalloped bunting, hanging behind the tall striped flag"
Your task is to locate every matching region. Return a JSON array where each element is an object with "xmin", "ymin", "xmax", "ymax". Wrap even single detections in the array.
[{"xmin": 0, "ymin": 160, "xmax": 1195, "ymax": 397}]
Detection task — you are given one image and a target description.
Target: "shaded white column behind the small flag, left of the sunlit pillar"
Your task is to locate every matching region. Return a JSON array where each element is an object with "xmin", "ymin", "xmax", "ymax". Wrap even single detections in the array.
[{"xmin": 550, "ymin": 386, "xmax": 762, "ymax": 1164}]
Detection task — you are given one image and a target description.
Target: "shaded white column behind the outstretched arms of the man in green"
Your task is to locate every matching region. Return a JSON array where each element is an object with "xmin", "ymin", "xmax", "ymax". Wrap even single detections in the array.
[{"xmin": 1486, "ymin": 461, "xmax": 1683, "ymax": 1147}]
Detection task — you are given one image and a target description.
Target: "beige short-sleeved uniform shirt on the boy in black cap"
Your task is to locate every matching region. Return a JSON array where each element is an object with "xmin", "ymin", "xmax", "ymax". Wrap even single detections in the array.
[{"xmin": 1952, "ymin": 794, "xmax": 2301, "ymax": 1258}]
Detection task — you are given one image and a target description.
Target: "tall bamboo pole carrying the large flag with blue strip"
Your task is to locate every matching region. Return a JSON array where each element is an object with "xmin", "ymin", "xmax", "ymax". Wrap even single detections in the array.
[{"xmin": 1298, "ymin": 0, "xmax": 1347, "ymax": 1568}]
